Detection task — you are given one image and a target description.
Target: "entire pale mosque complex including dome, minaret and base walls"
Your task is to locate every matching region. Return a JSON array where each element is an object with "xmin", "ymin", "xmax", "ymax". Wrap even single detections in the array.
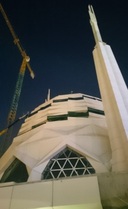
[{"xmin": 0, "ymin": 6, "xmax": 128, "ymax": 209}]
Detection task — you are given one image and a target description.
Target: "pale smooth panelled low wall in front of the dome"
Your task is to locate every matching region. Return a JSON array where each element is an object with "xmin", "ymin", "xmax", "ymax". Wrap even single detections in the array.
[{"xmin": 0, "ymin": 176, "xmax": 102, "ymax": 209}]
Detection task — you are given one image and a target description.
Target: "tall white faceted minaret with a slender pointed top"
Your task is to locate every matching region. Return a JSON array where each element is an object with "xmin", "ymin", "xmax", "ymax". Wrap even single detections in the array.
[{"xmin": 89, "ymin": 6, "xmax": 128, "ymax": 172}]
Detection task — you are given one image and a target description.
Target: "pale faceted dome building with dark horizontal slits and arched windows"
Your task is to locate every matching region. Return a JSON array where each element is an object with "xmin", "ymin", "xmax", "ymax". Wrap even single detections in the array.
[{"xmin": 0, "ymin": 94, "xmax": 111, "ymax": 182}]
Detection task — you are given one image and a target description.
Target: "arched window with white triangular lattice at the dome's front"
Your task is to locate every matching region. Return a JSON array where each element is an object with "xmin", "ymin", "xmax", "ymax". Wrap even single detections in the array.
[{"xmin": 41, "ymin": 148, "xmax": 95, "ymax": 179}]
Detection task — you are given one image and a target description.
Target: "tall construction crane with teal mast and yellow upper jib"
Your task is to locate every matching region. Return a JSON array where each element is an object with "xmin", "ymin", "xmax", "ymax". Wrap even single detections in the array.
[{"xmin": 0, "ymin": 4, "xmax": 34, "ymax": 152}]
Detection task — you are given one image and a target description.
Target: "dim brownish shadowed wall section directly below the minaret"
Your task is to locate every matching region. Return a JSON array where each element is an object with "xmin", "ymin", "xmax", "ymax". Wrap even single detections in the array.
[{"xmin": 98, "ymin": 172, "xmax": 128, "ymax": 209}]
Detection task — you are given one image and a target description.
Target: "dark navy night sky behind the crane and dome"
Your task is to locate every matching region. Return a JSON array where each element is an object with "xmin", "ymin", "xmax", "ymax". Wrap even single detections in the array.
[{"xmin": 0, "ymin": 0, "xmax": 128, "ymax": 130}]
